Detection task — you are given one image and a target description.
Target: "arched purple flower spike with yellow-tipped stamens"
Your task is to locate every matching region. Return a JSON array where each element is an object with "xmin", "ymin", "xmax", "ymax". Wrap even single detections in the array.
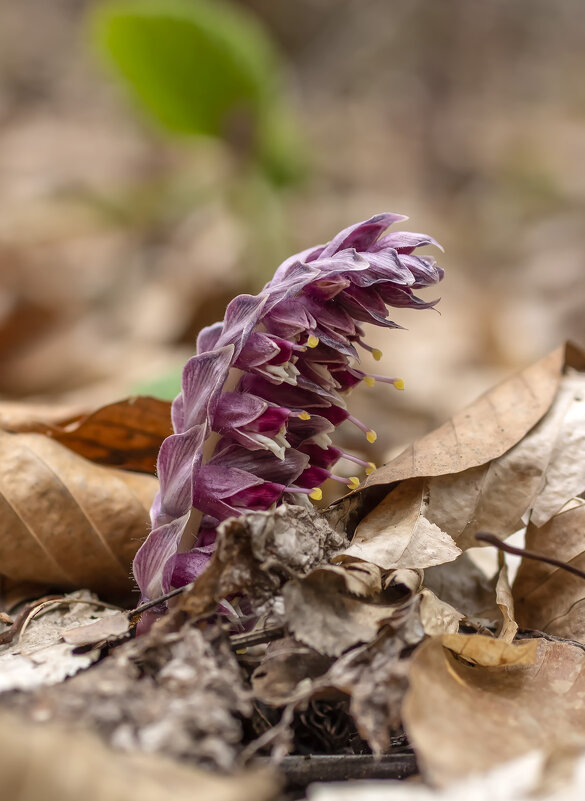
[{"xmin": 134, "ymin": 214, "xmax": 443, "ymax": 601}]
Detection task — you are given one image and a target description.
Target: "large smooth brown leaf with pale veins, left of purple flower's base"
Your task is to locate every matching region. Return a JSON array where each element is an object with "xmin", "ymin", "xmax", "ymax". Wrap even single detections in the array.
[{"xmin": 0, "ymin": 432, "xmax": 158, "ymax": 600}]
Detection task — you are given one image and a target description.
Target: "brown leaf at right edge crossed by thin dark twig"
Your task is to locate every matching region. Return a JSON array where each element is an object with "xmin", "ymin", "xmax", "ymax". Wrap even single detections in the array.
[{"xmin": 513, "ymin": 501, "xmax": 585, "ymax": 643}]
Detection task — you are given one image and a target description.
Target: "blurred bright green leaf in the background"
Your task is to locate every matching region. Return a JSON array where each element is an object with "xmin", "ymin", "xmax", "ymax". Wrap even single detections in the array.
[{"xmin": 92, "ymin": 0, "xmax": 300, "ymax": 183}]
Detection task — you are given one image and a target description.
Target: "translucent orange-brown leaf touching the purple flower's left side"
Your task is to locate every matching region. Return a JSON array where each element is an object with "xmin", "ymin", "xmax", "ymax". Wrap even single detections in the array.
[{"xmin": 8, "ymin": 396, "xmax": 172, "ymax": 473}]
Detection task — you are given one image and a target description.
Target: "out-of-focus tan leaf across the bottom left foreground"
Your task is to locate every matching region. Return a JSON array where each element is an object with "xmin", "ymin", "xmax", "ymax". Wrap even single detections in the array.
[{"xmin": 0, "ymin": 712, "xmax": 280, "ymax": 801}]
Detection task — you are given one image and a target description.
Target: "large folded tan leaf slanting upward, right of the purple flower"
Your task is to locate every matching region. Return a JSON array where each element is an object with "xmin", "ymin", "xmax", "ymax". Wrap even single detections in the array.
[{"xmin": 341, "ymin": 347, "xmax": 585, "ymax": 567}]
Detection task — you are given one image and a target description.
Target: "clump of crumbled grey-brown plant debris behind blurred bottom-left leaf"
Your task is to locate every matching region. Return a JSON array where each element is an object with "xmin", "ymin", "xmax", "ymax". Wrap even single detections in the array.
[{"xmin": 7, "ymin": 625, "xmax": 251, "ymax": 770}]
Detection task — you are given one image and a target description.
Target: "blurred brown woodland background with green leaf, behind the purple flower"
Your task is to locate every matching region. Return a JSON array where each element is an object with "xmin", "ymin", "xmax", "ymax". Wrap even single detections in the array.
[{"xmin": 0, "ymin": 0, "xmax": 585, "ymax": 468}]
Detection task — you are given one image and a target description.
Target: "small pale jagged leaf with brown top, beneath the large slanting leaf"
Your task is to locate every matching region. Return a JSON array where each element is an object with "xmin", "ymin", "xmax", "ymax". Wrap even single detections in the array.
[{"xmin": 344, "ymin": 479, "xmax": 461, "ymax": 570}]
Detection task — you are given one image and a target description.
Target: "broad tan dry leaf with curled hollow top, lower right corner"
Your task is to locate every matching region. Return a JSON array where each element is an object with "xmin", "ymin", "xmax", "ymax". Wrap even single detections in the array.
[{"xmin": 403, "ymin": 634, "xmax": 585, "ymax": 786}]
